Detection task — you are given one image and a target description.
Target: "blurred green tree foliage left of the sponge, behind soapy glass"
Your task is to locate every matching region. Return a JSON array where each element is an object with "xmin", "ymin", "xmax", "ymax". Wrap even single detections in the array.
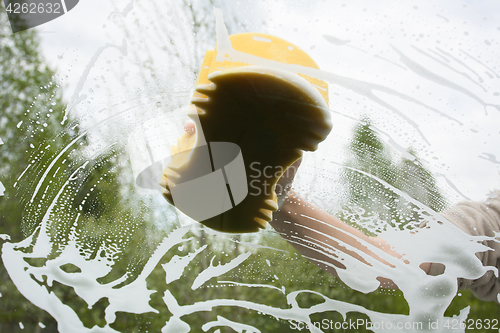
[{"xmin": 0, "ymin": 6, "xmax": 163, "ymax": 332}]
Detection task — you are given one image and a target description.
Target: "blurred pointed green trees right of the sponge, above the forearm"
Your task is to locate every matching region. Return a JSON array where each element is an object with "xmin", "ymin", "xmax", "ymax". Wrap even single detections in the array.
[{"xmin": 341, "ymin": 118, "xmax": 445, "ymax": 232}]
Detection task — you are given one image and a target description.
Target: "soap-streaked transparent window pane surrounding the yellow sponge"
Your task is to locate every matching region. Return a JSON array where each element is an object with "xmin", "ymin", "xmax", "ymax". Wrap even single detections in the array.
[{"xmin": 0, "ymin": 1, "xmax": 500, "ymax": 333}]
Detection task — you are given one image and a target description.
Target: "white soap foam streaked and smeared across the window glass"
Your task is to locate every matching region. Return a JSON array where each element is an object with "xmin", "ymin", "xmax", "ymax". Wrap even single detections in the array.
[{"xmin": 0, "ymin": 3, "xmax": 498, "ymax": 333}]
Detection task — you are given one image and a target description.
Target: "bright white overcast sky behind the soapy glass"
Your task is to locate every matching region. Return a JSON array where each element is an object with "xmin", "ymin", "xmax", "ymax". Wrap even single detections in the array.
[{"xmin": 38, "ymin": 0, "xmax": 500, "ymax": 201}]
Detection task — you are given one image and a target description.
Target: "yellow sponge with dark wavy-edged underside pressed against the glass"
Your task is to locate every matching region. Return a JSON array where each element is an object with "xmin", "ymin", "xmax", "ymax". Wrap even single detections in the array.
[{"xmin": 161, "ymin": 33, "xmax": 331, "ymax": 232}]
